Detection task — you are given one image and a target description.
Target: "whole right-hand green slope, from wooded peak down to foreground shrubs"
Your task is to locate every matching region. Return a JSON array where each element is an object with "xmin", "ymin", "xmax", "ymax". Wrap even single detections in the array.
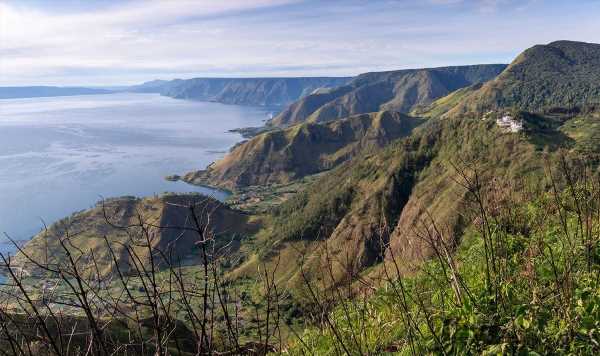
[{"xmin": 256, "ymin": 42, "xmax": 600, "ymax": 355}]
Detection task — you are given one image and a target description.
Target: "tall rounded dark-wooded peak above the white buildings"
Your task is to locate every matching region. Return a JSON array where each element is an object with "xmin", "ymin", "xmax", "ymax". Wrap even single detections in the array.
[{"xmin": 433, "ymin": 41, "xmax": 600, "ymax": 115}]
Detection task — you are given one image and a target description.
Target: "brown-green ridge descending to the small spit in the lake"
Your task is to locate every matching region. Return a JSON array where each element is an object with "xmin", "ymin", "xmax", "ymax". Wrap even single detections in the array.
[{"xmin": 183, "ymin": 111, "xmax": 422, "ymax": 189}]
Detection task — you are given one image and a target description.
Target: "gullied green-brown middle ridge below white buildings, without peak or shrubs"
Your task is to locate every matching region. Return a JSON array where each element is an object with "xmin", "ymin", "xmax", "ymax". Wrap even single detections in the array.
[{"xmin": 238, "ymin": 108, "xmax": 597, "ymax": 286}]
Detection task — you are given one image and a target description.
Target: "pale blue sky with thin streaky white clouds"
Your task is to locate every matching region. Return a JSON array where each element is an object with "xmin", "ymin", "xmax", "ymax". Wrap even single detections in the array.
[{"xmin": 0, "ymin": 0, "xmax": 600, "ymax": 86}]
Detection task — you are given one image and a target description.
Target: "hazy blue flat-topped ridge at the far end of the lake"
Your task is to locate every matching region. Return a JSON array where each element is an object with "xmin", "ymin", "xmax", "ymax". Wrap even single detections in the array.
[{"xmin": 129, "ymin": 77, "xmax": 352, "ymax": 106}]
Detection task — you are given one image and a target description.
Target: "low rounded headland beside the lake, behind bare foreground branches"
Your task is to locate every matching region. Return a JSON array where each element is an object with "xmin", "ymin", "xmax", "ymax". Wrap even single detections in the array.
[{"xmin": 16, "ymin": 194, "xmax": 254, "ymax": 275}]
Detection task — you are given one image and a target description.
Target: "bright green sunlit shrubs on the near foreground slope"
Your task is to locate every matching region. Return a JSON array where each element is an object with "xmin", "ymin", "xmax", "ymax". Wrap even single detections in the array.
[{"xmin": 290, "ymin": 177, "xmax": 600, "ymax": 355}]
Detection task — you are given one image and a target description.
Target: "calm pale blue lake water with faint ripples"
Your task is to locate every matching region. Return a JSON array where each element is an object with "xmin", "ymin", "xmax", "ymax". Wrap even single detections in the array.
[{"xmin": 0, "ymin": 94, "xmax": 268, "ymax": 252}]
